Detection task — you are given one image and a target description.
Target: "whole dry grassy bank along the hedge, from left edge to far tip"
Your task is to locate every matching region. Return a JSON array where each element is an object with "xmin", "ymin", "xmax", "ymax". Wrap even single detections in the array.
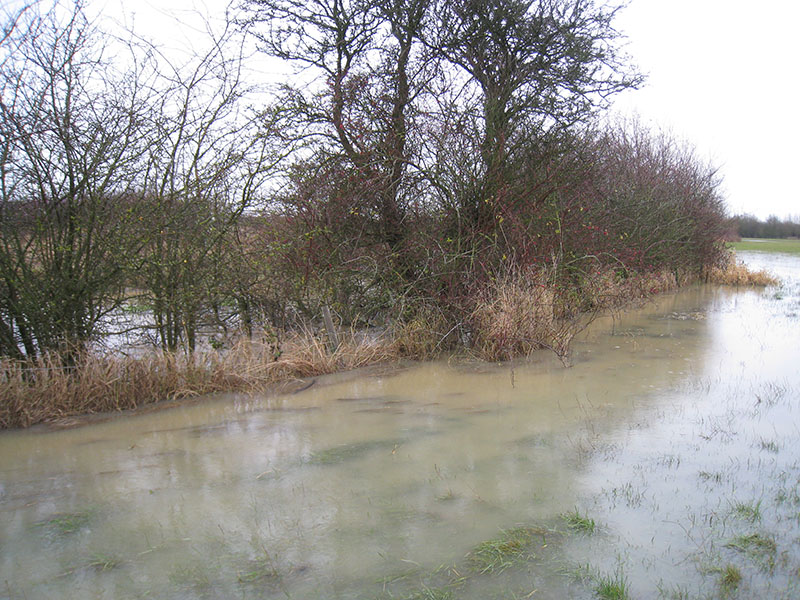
[{"xmin": 0, "ymin": 259, "xmax": 775, "ymax": 429}]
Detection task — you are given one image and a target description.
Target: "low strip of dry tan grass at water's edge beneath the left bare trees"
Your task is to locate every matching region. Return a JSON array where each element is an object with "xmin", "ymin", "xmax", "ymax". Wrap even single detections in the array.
[{"xmin": 0, "ymin": 334, "xmax": 398, "ymax": 429}]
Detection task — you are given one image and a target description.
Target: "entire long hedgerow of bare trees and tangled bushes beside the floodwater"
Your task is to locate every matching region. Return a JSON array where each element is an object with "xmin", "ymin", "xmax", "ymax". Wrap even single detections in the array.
[{"xmin": 0, "ymin": 0, "xmax": 726, "ymax": 422}]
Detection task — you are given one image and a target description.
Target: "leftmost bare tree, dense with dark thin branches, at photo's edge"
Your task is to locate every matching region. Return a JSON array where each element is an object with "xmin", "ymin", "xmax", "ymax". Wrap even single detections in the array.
[{"xmin": 0, "ymin": 2, "xmax": 158, "ymax": 356}]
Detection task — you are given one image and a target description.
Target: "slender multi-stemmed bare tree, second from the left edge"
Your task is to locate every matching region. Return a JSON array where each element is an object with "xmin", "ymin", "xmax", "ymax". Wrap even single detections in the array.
[{"xmin": 140, "ymin": 21, "xmax": 282, "ymax": 351}]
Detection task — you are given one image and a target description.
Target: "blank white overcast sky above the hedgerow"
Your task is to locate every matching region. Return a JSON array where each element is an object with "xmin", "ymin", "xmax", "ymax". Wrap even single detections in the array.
[{"xmin": 91, "ymin": 0, "xmax": 800, "ymax": 221}]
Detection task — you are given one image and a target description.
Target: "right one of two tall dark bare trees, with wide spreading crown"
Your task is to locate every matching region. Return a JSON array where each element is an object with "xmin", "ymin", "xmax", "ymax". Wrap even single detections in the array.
[{"xmin": 429, "ymin": 0, "xmax": 641, "ymax": 231}]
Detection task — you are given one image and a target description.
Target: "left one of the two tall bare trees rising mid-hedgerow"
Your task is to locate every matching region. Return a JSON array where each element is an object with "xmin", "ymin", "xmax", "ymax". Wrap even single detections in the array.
[{"xmin": 245, "ymin": 0, "xmax": 431, "ymax": 264}]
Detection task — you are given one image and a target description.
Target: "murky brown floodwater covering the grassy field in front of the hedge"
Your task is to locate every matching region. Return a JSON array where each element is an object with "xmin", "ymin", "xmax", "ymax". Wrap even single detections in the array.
[{"xmin": 0, "ymin": 254, "xmax": 800, "ymax": 600}]
